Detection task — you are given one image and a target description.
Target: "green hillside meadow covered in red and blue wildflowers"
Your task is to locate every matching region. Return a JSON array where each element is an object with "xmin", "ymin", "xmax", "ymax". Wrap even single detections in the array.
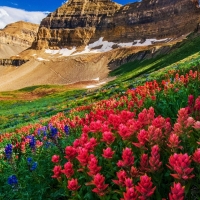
[{"xmin": 0, "ymin": 33, "xmax": 200, "ymax": 200}]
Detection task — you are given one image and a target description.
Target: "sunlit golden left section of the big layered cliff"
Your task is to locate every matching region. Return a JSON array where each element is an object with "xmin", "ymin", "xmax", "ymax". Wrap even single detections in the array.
[{"xmin": 34, "ymin": 0, "xmax": 121, "ymax": 49}]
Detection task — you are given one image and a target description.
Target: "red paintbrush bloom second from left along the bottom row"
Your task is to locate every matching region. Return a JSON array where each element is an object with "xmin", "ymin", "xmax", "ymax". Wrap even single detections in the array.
[{"xmin": 92, "ymin": 173, "xmax": 108, "ymax": 196}]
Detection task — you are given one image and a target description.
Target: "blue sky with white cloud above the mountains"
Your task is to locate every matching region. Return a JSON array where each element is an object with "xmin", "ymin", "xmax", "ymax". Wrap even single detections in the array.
[{"xmin": 0, "ymin": 0, "xmax": 136, "ymax": 29}]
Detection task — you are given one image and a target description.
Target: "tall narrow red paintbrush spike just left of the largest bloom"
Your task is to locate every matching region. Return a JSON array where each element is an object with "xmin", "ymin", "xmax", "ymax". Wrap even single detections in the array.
[{"xmin": 149, "ymin": 145, "xmax": 162, "ymax": 172}]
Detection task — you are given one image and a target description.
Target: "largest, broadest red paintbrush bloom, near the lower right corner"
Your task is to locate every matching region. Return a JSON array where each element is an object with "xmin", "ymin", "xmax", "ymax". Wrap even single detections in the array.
[{"xmin": 167, "ymin": 153, "xmax": 194, "ymax": 180}]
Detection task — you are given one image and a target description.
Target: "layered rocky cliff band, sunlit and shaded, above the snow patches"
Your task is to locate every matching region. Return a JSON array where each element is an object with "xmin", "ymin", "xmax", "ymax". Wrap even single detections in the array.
[{"xmin": 33, "ymin": 0, "xmax": 200, "ymax": 49}]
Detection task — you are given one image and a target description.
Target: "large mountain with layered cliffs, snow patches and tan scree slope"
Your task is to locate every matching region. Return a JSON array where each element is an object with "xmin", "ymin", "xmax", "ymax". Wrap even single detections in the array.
[{"xmin": 0, "ymin": 0, "xmax": 200, "ymax": 90}]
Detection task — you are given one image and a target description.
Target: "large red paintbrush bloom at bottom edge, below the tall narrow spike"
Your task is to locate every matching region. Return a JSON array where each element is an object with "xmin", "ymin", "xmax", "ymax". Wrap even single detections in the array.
[{"xmin": 136, "ymin": 175, "xmax": 156, "ymax": 200}]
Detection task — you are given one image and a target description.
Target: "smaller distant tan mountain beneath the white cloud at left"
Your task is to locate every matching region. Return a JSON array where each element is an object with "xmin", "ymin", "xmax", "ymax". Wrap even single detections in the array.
[{"xmin": 0, "ymin": 21, "xmax": 39, "ymax": 59}]
